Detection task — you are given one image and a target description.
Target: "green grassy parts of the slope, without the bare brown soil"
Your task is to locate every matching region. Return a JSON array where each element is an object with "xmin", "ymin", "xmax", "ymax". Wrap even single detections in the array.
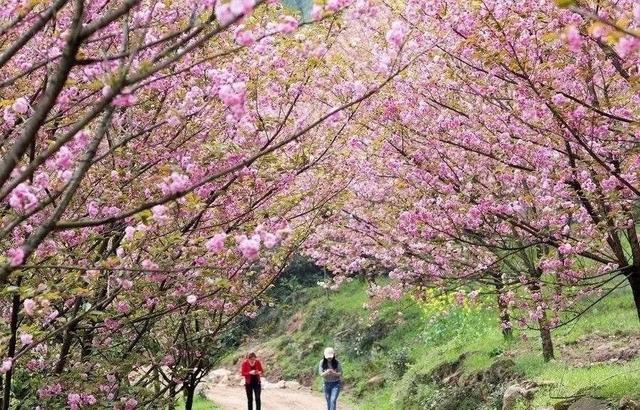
[{"xmin": 221, "ymin": 282, "xmax": 640, "ymax": 410}]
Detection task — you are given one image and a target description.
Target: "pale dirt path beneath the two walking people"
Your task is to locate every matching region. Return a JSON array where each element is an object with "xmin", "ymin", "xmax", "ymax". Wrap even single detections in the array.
[{"xmin": 205, "ymin": 386, "xmax": 348, "ymax": 410}]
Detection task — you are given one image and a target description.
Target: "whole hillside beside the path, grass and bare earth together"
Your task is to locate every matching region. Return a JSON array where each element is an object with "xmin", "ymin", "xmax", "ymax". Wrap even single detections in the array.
[{"xmin": 216, "ymin": 281, "xmax": 640, "ymax": 410}]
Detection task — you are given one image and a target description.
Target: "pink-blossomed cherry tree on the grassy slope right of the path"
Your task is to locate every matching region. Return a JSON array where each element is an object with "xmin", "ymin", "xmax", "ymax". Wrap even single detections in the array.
[{"xmin": 309, "ymin": 1, "xmax": 640, "ymax": 359}]
